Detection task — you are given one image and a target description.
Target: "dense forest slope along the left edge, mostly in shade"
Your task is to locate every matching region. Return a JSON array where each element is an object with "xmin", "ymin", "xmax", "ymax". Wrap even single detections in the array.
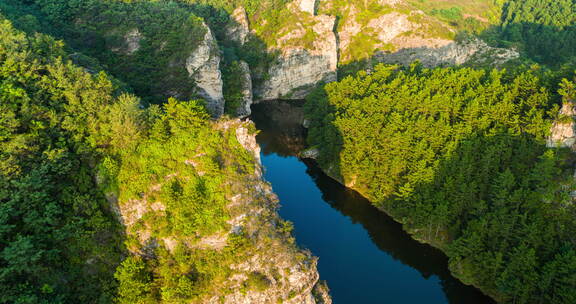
[{"xmin": 0, "ymin": 17, "xmax": 126, "ymax": 303}]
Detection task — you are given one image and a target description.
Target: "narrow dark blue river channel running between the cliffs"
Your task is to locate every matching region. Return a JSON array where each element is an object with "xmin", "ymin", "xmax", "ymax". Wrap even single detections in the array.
[{"xmin": 252, "ymin": 101, "xmax": 493, "ymax": 304}]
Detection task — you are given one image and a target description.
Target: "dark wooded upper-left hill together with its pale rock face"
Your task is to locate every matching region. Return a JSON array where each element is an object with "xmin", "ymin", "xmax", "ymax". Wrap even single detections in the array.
[{"xmin": 41, "ymin": 1, "xmax": 230, "ymax": 117}]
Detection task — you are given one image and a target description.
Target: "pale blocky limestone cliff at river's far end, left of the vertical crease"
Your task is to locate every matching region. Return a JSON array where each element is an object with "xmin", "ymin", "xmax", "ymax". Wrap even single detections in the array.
[{"xmin": 255, "ymin": 16, "xmax": 338, "ymax": 101}]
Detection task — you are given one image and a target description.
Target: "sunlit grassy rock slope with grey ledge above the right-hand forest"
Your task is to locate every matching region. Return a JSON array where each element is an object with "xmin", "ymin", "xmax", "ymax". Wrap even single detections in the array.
[{"xmin": 325, "ymin": 0, "xmax": 519, "ymax": 67}]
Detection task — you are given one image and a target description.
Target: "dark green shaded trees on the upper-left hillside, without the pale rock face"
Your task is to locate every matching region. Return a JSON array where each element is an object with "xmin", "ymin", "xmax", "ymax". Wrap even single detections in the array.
[{"xmin": 29, "ymin": 0, "xmax": 206, "ymax": 103}]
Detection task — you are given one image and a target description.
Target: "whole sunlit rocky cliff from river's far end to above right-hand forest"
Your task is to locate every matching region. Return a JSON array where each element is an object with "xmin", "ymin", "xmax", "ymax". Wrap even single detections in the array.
[{"xmin": 240, "ymin": 0, "xmax": 519, "ymax": 102}]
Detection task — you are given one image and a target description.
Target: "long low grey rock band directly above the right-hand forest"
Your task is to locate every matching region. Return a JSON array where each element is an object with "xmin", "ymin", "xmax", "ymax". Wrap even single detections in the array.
[{"xmin": 375, "ymin": 39, "xmax": 520, "ymax": 67}]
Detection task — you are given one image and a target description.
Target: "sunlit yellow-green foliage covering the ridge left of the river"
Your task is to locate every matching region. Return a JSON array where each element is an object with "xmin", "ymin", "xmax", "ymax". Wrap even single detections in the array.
[{"xmin": 107, "ymin": 99, "xmax": 292, "ymax": 304}]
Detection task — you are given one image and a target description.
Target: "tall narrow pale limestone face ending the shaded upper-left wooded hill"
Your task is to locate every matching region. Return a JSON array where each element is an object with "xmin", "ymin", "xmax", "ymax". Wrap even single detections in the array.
[{"xmin": 186, "ymin": 24, "xmax": 224, "ymax": 117}]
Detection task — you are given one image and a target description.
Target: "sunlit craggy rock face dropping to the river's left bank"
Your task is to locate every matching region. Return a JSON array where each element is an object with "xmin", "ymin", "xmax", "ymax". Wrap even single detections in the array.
[{"xmin": 212, "ymin": 120, "xmax": 331, "ymax": 304}]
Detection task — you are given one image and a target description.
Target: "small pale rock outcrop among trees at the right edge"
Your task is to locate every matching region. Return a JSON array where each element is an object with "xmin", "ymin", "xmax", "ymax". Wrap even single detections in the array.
[{"xmin": 546, "ymin": 101, "xmax": 576, "ymax": 149}]
